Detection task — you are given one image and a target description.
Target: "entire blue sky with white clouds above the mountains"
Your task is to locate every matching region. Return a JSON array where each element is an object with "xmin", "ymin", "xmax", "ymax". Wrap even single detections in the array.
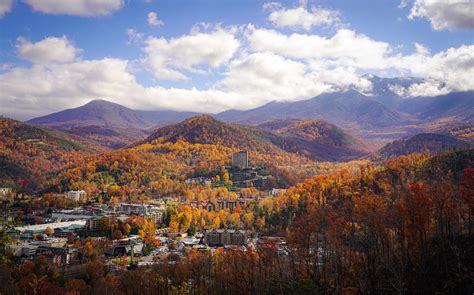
[{"xmin": 0, "ymin": 0, "xmax": 474, "ymax": 120}]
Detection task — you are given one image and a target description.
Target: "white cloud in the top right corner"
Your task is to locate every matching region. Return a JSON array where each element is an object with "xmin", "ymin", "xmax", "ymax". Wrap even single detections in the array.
[{"xmin": 408, "ymin": 0, "xmax": 474, "ymax": 30}]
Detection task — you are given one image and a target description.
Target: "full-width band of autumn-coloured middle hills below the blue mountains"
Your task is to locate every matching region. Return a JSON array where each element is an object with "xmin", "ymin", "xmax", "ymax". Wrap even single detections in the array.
[{"xmin": 0, "ymin": 110, "xmax": 474, "ymax": 190}]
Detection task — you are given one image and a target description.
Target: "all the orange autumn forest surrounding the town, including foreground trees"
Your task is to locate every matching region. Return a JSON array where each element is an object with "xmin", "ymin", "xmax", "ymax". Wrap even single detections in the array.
[{"xmin": 0, "ymin": 115, "xmax": 474, "ymax": 294}]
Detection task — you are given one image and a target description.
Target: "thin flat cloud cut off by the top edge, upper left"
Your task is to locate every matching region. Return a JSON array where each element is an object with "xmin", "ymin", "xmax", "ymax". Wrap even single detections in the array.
[{"xmin": 24, "ymin": 0, "xmax": 124, "ymax": 16}]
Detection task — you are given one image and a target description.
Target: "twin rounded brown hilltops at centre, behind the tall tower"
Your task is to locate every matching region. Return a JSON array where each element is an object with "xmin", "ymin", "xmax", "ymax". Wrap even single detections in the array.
[{"xmin": 144, "ymin": 115, "xmax": 366, "ymax": 161}]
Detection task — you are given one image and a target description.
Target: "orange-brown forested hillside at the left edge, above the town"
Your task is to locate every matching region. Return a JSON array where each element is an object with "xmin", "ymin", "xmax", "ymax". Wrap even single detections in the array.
[{"xmin": 0, "ymin": 118, "xmax": 91, "ymax": 191}]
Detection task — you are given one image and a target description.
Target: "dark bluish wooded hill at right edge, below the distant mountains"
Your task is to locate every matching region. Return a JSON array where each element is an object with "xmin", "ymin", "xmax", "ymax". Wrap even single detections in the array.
[{"xmin": 372, "ymin": 133, "xmax": 474, "ymax": 160}]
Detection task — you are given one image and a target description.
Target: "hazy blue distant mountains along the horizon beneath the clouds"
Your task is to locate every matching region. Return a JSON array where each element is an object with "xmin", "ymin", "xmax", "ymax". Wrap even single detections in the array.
[{"xmin": 28, "ymin": 75, "xmax": 474, "ymax": 150}]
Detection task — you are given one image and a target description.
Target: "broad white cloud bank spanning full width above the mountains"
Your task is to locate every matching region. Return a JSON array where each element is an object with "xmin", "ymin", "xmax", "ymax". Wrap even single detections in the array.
[{"xmin": 0, "ymin": 24, "xmax": 474, "ymax": 119}]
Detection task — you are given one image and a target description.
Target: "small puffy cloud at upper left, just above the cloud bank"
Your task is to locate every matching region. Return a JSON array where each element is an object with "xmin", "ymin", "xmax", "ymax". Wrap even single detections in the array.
[{"xmin": 16, "ymin": 36, "xmax": 82, "ymax": 63}]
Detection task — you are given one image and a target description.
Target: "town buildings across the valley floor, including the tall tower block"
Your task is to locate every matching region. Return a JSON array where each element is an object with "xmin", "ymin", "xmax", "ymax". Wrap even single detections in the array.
[{"xmin": 0, "ymin": 151, "xmax": 286, "ymax": 277}]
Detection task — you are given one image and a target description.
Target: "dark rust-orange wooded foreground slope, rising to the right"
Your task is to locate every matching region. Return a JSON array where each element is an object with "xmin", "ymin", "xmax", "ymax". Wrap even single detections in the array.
[{"xmin": 2, "ymin": 151, "xmax": 474, "ymax": 294}]
